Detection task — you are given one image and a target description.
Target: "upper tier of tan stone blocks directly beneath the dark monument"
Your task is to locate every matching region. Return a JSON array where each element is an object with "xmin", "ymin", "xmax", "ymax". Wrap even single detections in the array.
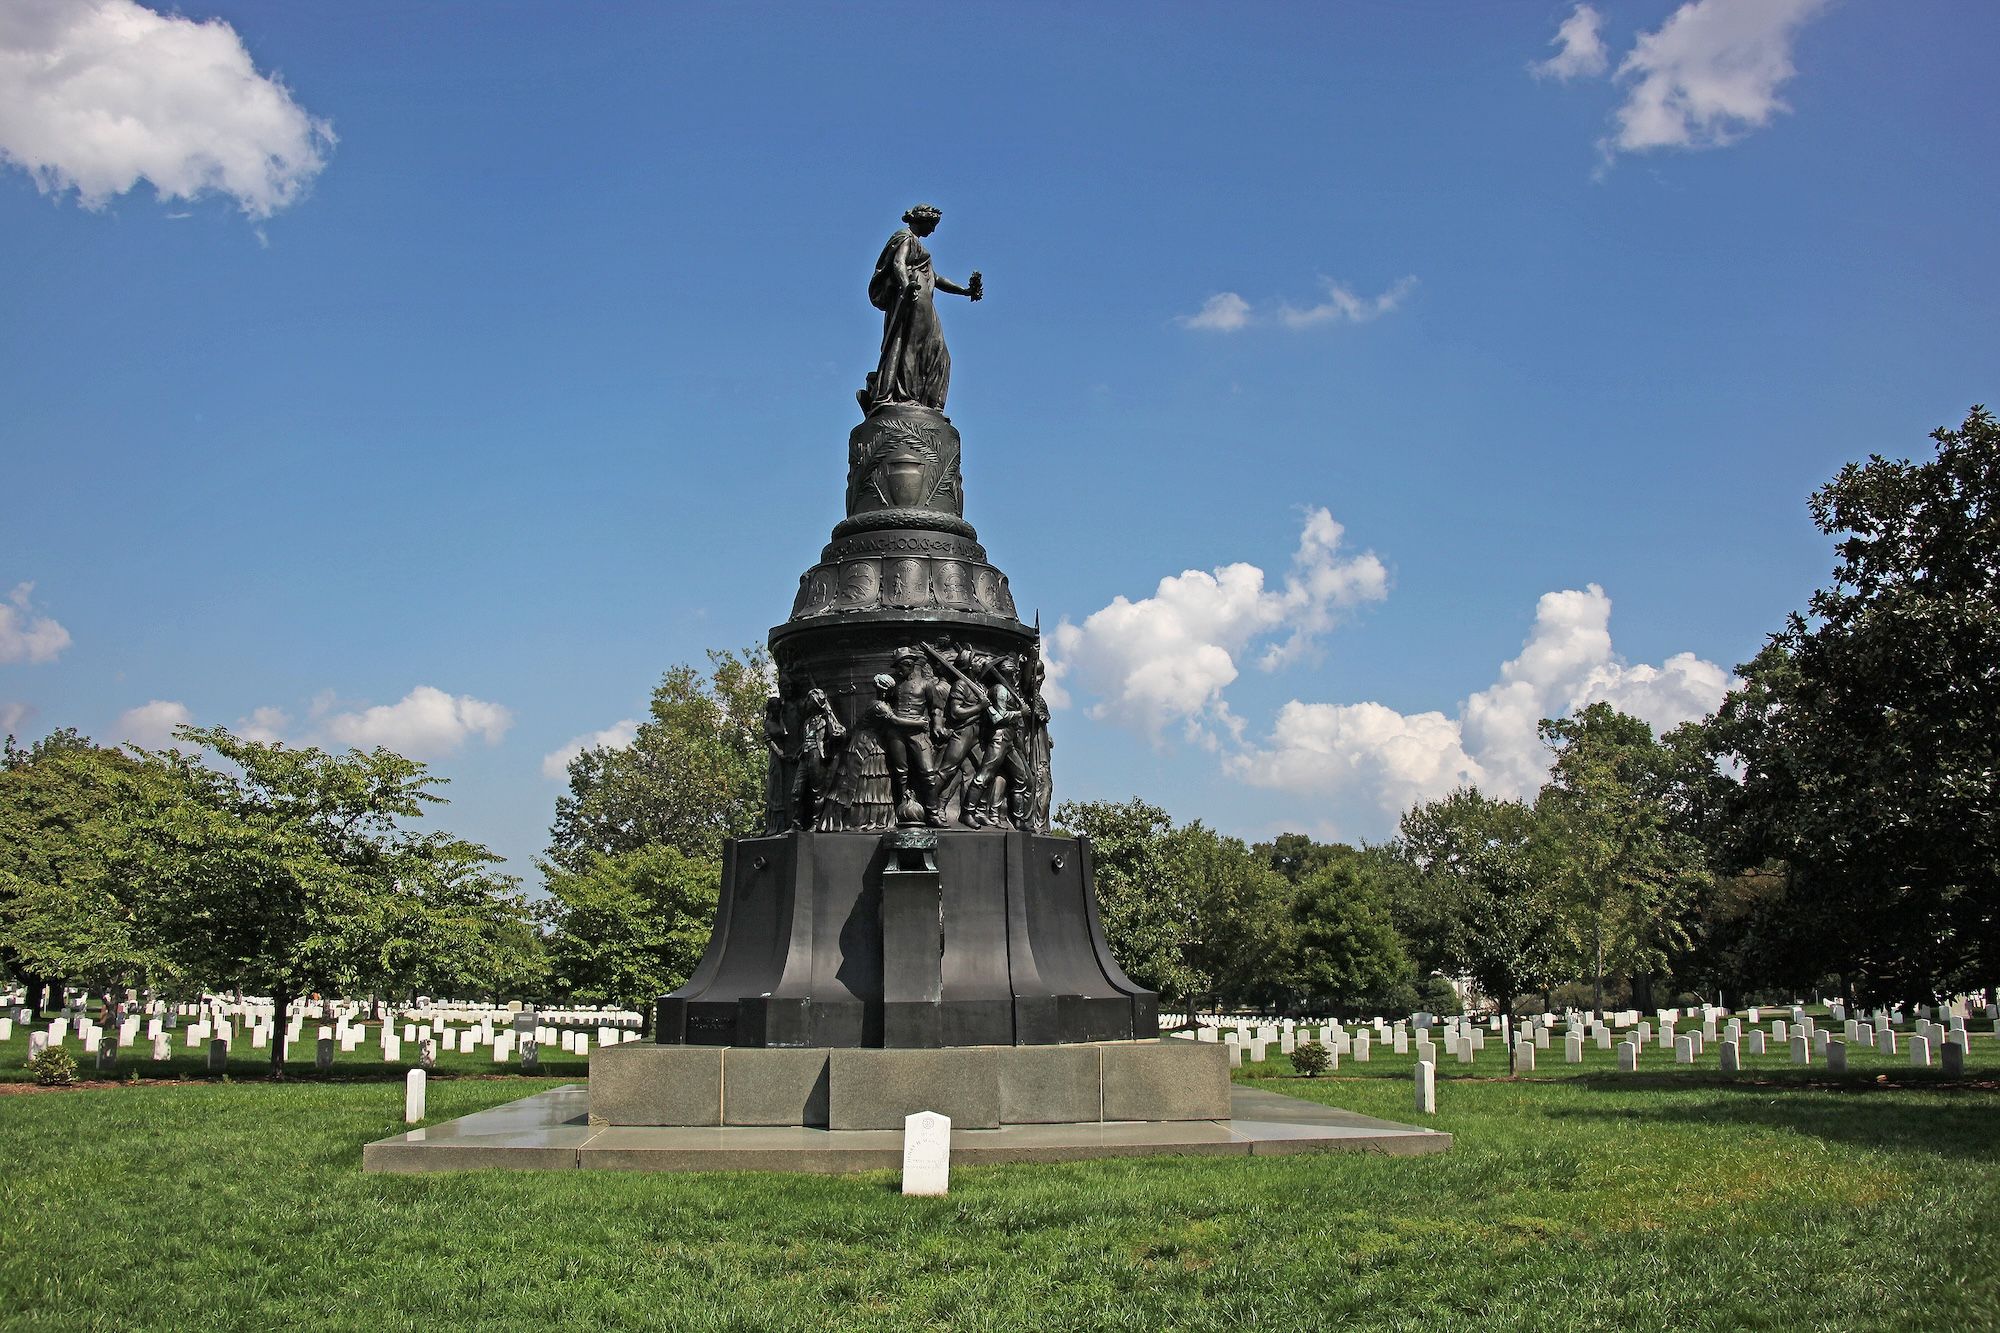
[{"xmin": 590, "ymin": 1039, "xmax": 1230, "ymax": 1131}]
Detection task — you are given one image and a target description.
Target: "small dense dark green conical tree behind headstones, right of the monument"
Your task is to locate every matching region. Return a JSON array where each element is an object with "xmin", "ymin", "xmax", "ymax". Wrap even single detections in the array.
[{"xmin": 1288, "ymin": 857, "xmax": 1412, "ymax": 1013}]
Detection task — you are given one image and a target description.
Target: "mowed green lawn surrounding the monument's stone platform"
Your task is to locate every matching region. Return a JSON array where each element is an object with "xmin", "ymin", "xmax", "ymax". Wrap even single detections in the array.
[{"xmin": 0, "ymin": 1016, "xmax": 2000, "ymax": 1331}]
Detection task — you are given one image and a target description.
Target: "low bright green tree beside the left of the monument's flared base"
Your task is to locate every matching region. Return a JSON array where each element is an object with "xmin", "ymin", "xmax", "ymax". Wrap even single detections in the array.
[{"xmin": 542, "ymin": 847, "xmax": 722, "ymax": 1023}]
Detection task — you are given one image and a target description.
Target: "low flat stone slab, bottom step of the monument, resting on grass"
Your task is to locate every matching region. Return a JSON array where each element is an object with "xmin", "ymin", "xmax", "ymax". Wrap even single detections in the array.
[{"xmin": 362, "ymin": 1083, "xmax": 1452, "ymax": 1175}]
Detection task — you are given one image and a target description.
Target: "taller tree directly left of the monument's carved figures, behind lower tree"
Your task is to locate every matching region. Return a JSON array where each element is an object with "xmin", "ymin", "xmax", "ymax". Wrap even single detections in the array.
[{"xmin": 548, "ymin": 648, "xmax": 770, "ymax": 873}]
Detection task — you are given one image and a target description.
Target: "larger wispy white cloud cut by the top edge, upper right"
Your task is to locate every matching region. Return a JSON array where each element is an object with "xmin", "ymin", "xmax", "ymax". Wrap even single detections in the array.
[{"xmin": 1600, "ymin": 0, "xmax": 1826, "ymax": 158}]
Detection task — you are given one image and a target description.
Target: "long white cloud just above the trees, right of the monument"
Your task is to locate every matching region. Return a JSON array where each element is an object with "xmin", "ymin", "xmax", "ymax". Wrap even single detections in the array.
[{"xmin": 1224, "ymin": 584, "xmax": 1734, "ymax": 823}]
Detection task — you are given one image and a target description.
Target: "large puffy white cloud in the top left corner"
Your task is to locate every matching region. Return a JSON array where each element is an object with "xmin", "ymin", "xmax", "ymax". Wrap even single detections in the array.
[{"xmin": 0, "ymin": 0, "xmax": 334, "ymax": 220}]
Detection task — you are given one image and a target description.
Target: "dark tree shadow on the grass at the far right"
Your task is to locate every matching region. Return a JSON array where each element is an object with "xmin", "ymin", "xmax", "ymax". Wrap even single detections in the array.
[{"xmin": 1546, "ymin": 1071, "xmax": 2000, "ymax": 1161}]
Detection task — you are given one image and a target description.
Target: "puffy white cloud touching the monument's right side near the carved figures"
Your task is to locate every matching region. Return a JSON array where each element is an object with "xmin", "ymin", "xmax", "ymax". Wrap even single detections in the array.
[{"xmin": 1046, "ymin": 508, "xmax": 1388, "ymax": 737}]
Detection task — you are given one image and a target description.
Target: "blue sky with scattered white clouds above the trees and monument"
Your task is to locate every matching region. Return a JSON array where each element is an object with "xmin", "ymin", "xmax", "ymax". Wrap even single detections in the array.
[{"xmin": 0, "ymin": 0, "xmax": 2000, "ymax": 879}]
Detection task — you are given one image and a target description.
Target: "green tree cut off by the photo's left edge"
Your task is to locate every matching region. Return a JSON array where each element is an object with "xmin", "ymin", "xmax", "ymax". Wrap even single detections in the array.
[{"xmin": 0, "ymin": 729, "xmax": 166, "ymax": 1011}]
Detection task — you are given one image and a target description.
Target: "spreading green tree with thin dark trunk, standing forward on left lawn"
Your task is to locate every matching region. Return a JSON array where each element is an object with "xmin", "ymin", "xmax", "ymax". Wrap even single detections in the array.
[{"xmin": 134, "ymin": 727, "xmax": 462, "ymax": 1077}]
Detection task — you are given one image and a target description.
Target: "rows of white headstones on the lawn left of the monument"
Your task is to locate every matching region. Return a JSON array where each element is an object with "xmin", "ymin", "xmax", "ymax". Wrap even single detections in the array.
[{"xmin": 0, "ymin": 997, "xmax": 640, "ymax": 1071}]
